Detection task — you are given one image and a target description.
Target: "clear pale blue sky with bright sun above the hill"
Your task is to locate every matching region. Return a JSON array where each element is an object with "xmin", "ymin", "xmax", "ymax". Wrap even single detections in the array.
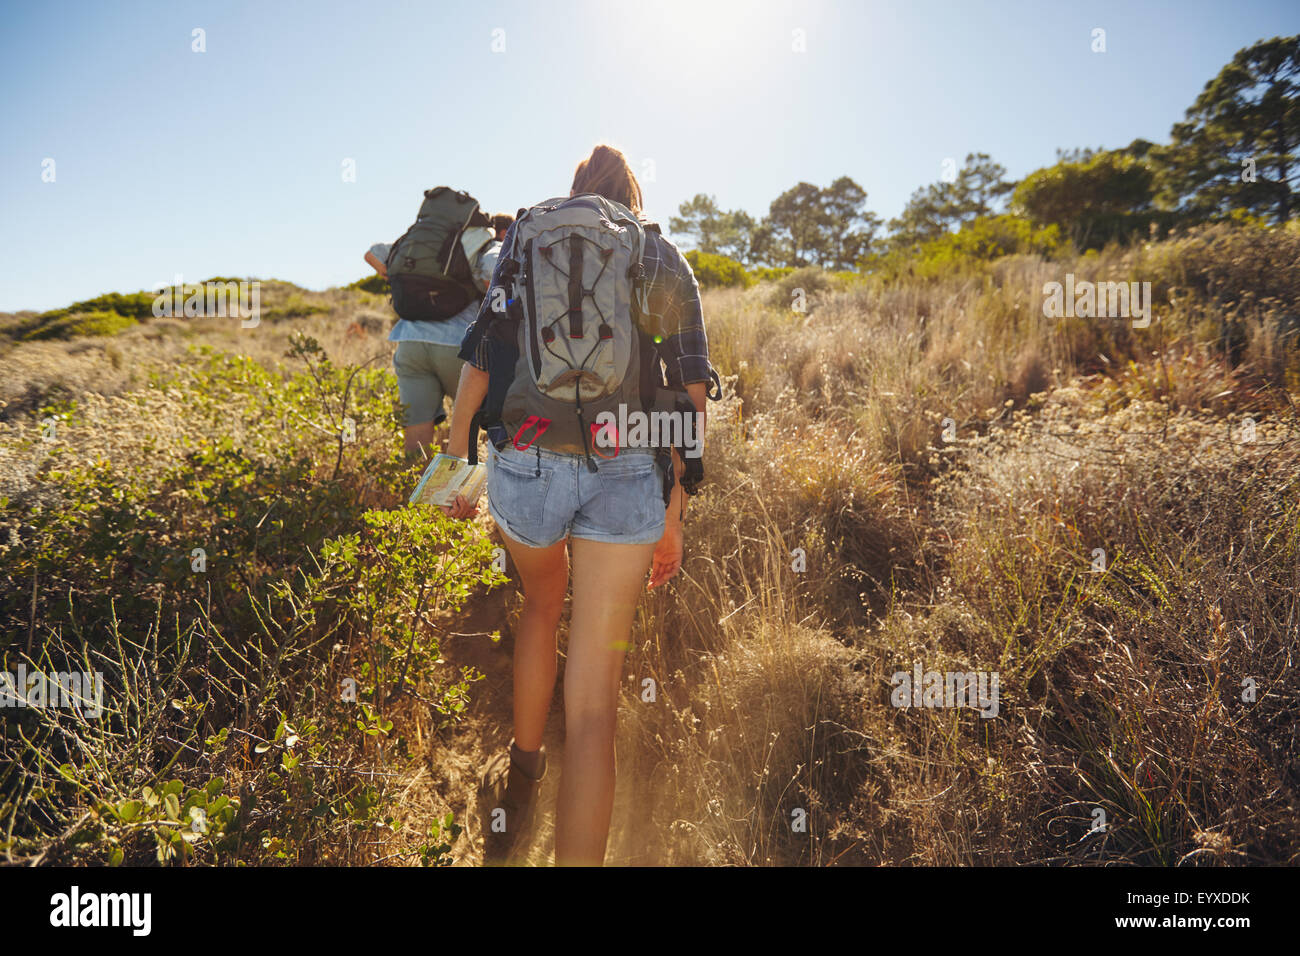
[{"xmin": 0, "ymin": 0, "xmax": 1300, "ymax": 311}]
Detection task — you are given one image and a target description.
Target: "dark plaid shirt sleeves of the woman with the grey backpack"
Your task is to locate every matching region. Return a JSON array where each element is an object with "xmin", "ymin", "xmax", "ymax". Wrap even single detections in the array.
[{"xmin": 460, "ymin": 218, "xmax": 710, "ymax": 388}]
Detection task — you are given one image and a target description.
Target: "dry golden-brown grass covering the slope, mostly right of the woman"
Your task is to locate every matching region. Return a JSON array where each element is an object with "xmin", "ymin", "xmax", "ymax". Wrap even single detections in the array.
[{"xmin": 0, "ymin": 228, "xmax": 1300, "ymax": 865}]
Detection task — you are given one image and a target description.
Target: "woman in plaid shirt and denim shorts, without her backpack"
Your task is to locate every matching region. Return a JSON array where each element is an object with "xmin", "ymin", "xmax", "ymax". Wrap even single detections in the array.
[{"xmin": 445, "ymin": 146, "xmax": 711, "ymax": 866}]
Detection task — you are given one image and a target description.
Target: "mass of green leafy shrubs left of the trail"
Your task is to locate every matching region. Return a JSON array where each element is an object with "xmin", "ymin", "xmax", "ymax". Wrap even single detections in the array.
[{"xmin": 0, "ymin": 337, "xmax": 502, "ymax": 865}]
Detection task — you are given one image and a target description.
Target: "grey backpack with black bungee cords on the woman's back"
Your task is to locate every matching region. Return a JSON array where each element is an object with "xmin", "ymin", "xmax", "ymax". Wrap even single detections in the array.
[{"xmin": 501, "ymin": 194, "xmax": 657, "ymax": 471}]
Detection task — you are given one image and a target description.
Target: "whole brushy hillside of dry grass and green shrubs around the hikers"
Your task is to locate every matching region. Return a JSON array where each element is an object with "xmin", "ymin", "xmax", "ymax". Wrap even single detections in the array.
[{"xmin": 0, "ymin": 228, "xmax": 1300, "ymax": 865}]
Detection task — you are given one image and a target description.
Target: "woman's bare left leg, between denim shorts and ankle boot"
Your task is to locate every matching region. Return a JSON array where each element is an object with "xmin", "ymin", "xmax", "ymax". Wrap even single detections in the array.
[{"xmin": 491, "ymin": 529, "xmax": 568, "ymax": 750}]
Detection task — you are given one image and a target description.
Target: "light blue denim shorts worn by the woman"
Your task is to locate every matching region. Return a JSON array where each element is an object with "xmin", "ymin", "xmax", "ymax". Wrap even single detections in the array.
[{"xmin": 488, "ymin": 445, "xmax": 666, "ymax": 548}]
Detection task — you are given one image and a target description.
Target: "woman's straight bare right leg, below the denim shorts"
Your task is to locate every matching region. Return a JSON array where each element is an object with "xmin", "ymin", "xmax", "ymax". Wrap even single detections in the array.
[{"xmin": 555, "ymin": 538, "xmax": 655, "ymax": 866}]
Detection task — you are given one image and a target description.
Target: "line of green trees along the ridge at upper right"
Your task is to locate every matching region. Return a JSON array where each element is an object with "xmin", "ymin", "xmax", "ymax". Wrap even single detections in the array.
[{"xmin": 668, "ymin": 35, "xmax": 1300, "ymax": 269}]
